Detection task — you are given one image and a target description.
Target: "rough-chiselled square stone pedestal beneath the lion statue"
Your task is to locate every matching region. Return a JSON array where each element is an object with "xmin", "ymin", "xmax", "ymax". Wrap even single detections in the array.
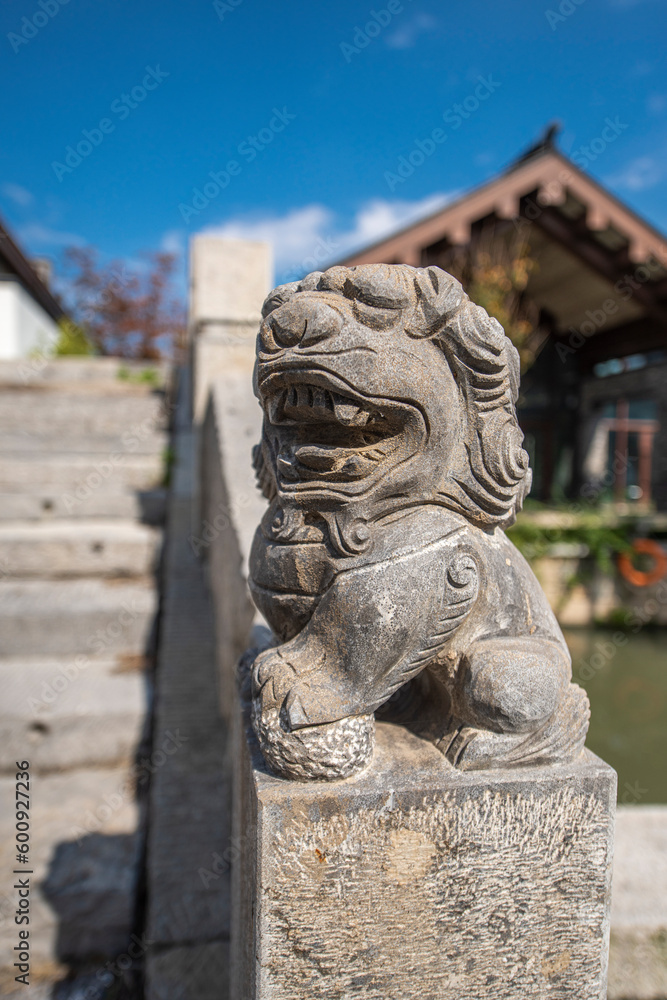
[{"xmin": 230, "ymin": 719, "xmax": 616, "ymax": 1000}]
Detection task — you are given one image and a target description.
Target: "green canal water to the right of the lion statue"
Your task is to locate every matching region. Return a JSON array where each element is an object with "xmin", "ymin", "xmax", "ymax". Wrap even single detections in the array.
[{"xmin": 563, "ymin": 628, "xmax": 667, "ymax": 805}]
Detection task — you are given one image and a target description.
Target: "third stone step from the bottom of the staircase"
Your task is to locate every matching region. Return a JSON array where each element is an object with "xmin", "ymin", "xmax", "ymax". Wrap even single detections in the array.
[{"xmin": 0, "ymin": 577, "xmax": 157, "ymax": 657}]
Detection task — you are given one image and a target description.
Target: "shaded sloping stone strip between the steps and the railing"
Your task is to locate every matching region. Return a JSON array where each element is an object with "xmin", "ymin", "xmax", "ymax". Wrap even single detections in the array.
[{"xmin": 146, "ymin": 370, "xmax": 231, "ymax": 1000}]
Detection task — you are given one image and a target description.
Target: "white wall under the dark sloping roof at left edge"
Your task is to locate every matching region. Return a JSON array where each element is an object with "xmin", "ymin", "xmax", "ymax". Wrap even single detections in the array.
[{"xmin": 0, "ymin": 279, "xmax": 59, "ymax": 361}]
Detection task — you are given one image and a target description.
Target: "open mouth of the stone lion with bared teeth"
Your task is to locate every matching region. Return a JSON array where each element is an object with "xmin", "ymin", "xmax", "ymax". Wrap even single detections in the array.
[{"xmin": 264, "ymin": 372, "xmax": 411, "ymax": 481}]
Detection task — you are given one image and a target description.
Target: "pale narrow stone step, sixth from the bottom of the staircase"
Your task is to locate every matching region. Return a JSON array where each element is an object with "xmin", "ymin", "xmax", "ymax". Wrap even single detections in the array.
[{"xmin": 0, "ymin": 452, "xmax": 164, "ymax": 494}]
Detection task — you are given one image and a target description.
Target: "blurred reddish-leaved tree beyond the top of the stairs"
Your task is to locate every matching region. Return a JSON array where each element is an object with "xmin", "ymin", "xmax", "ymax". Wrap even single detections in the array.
[{"xmin": 64, "ymin": 247, "xmax": 185, "ymax": 360}]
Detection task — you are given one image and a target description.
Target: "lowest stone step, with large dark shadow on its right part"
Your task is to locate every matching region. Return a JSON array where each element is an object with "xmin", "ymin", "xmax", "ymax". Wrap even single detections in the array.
[{"xmin": 0, "ymin": 758, "xmax": 140, "ymax": 976}]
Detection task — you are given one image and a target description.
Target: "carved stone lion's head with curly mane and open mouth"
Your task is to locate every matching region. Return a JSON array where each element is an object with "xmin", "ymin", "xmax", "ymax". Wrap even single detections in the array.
[{"xmin": 255, "ymin": 264, "xmax": 531, "ymax": 529}]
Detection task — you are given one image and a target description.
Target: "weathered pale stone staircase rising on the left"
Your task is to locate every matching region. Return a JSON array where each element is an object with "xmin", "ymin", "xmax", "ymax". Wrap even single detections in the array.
[{"xmin": 0, "ymin": 358, "xmax": 170, "ymax": 997}]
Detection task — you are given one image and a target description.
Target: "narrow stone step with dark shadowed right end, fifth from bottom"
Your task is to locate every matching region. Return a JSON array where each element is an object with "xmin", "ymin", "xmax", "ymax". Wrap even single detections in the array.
[{"xmin": 0, "ymin": 487, "xmax": 166, "ymax": 524}]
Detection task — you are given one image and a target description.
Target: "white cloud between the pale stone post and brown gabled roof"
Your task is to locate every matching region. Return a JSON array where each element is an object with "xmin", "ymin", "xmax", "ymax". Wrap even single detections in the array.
[{"xmin": 205, "ymin": 194, "xmax": 453, "ymax": 281}]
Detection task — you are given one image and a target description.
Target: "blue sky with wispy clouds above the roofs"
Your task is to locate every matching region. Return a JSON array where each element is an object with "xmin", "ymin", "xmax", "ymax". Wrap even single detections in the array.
[{"xmin": 0, "ymin": 0, "xmax": 667, "ymax": 292}]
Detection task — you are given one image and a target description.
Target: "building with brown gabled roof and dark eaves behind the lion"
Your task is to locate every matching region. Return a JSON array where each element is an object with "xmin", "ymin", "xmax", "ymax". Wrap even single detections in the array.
[{"xmin": 340, "ymin": 129, "xmax": 667, "ymax": 510}]
